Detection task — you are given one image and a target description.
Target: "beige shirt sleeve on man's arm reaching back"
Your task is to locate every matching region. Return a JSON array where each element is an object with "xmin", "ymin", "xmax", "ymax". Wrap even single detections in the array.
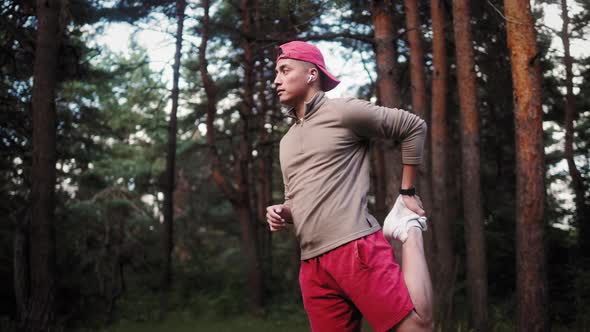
[{"xmin": 342, "ymin": 99, "xmax": 427, "ymax": 165}]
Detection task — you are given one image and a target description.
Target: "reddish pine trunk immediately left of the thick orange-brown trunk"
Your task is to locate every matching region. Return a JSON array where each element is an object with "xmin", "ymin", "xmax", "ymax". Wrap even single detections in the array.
[{"xmin": 453, "ymin": 0, "xmax": 488, "ymax": 332}]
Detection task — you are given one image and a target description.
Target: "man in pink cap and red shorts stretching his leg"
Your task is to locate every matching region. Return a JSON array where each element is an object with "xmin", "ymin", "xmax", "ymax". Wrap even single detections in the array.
[{"xmin": 266, "ymin": 41, "xmax": 433, "ymax": 332}]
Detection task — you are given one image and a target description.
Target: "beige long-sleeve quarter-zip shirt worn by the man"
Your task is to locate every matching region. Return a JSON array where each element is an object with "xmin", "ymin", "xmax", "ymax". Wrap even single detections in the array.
[{"xmin": 280, "ymin": 91, "xmax": 426, "ymax": 260}]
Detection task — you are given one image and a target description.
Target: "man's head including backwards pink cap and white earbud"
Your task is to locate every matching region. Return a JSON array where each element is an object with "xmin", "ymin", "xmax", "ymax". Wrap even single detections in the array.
[{"xmin": 274, "ymin": 41, "xmax": 340, "ymax": 105}]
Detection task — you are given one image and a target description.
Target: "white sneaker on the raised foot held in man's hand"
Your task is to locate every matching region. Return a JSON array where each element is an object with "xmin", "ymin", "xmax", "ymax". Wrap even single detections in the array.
[{"xmin": 383, "ymin": 195, "xmax": 428, "ymax": 243}]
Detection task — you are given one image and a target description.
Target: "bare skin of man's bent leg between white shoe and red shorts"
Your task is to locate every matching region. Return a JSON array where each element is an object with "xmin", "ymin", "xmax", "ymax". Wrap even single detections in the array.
[{"xmin": 393, "ymin": 227, "xmax": 434, "ymax": 332}]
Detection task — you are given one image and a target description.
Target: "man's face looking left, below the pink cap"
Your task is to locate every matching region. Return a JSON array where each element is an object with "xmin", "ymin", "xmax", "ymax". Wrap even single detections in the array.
[{"xmin": 274, "ymin": 59, "xmax": 313, "ymax": 106}]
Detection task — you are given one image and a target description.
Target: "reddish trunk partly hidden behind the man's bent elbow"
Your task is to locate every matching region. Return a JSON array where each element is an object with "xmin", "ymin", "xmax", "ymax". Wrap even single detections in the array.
[{"xmin": 404, "ymin": 0, "xmax": 436, "ymax": 275}]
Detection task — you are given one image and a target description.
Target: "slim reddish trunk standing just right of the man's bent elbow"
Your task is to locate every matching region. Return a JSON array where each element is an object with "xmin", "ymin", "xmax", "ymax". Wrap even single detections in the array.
[{"xmin": 430, "ymin": 0, "xmax": 455, "ymax": 323}]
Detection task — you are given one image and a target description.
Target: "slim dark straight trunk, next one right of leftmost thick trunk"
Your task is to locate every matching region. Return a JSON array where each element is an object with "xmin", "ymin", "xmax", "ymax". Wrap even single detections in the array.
[{"xmin": 160, "ymin": 0, "xmax": 186, "ymax": 315}]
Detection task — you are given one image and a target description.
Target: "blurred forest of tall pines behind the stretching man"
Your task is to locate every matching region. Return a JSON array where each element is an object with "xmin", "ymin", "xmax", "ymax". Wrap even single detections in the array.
[{"xmin": 0, "ymin": 0, "xmax": 590, "ymax": 331}]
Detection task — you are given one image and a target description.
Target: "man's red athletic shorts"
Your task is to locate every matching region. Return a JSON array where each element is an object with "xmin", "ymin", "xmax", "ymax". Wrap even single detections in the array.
[{"xmin": 299, "ymin": 230, "xmax": 414, "ymax": 332}]
